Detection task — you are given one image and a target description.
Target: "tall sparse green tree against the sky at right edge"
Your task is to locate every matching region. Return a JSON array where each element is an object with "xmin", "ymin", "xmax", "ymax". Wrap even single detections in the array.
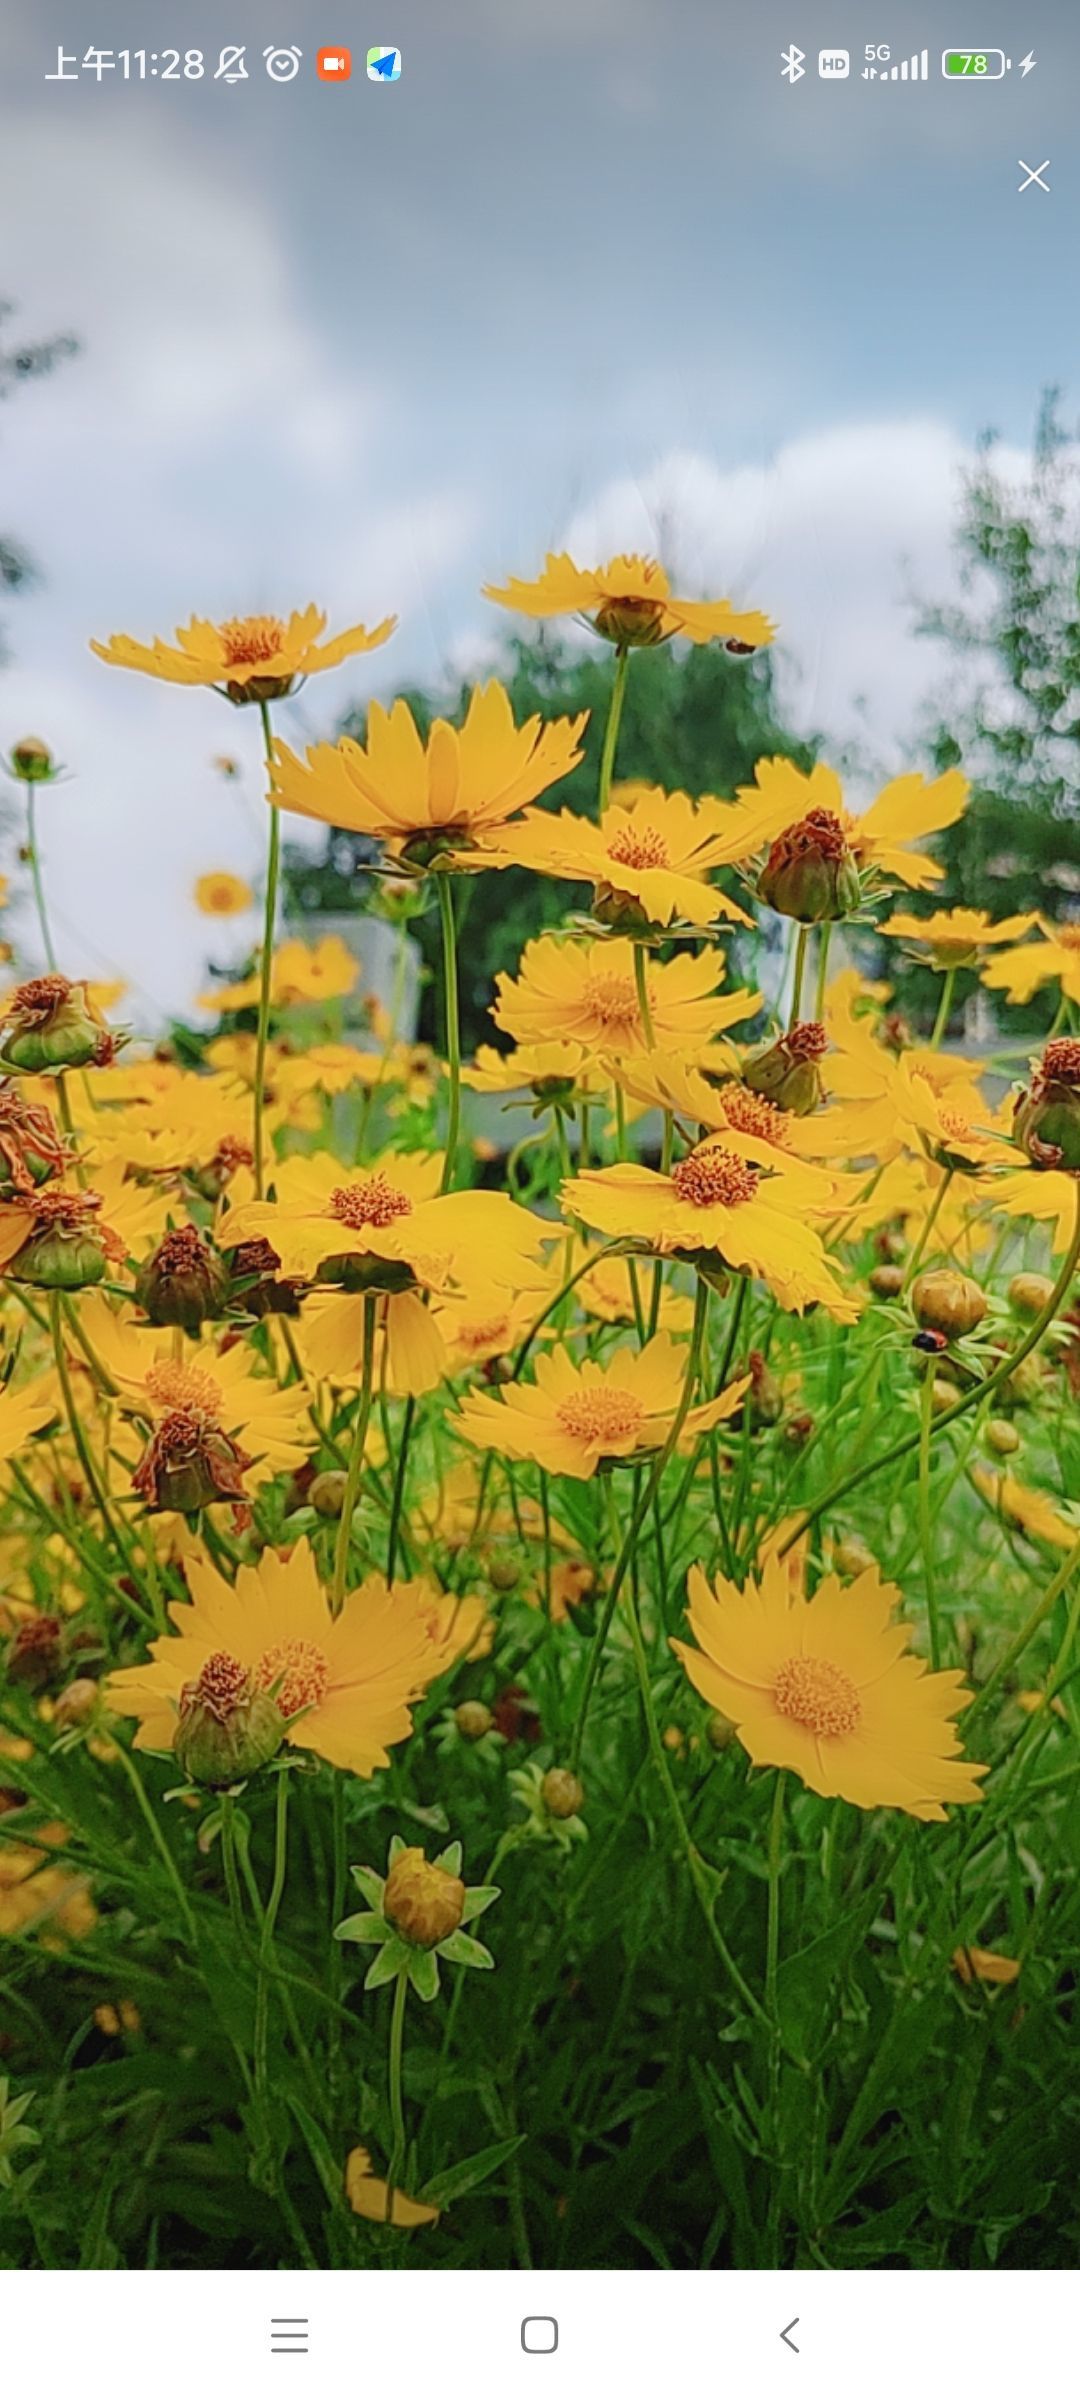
[{"xmin": 900, "ymin": 391, "xmax": 1080, "ymax": 1034}]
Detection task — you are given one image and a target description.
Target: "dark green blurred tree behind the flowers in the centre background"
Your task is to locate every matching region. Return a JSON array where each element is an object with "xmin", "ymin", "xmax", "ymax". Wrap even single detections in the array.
[{"xmin": 286, "ymin": 631, "xmax": 814, "ymax": 1046}]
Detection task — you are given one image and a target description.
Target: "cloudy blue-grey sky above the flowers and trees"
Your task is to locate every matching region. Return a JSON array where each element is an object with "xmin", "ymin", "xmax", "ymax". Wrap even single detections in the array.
[{"xmin": 0, "ymin": 0, "xmax": 1080, "ymax": 1013}]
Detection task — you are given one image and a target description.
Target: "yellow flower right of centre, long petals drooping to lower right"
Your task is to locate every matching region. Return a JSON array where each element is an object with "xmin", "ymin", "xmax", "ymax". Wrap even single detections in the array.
[{"xmin": 562, "ymin": 1133, "xmax": 859, "ymax": 1322}]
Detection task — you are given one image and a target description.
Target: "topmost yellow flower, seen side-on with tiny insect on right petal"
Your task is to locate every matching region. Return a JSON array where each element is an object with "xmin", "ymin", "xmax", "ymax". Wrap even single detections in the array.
[{"xmin": 485, "ymin": 552, "xmax": 775, "ymax": 658}]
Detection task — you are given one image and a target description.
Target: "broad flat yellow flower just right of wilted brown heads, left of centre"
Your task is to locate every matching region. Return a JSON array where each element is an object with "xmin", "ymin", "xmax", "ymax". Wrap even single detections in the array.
[{"xmin": 218, "ymin": 1150, "xmax": 552, "ymax": 1291}]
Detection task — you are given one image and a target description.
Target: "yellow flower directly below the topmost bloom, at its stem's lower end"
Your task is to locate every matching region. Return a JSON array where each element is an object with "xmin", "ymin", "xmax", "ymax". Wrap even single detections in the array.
[{"xmin": 499, "ymin": 782, "xmax": 749, "ymax": 931}]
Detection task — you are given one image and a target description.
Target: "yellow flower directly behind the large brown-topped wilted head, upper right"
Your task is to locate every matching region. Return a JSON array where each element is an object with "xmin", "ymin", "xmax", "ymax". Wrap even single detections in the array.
[{"xmin": 730, "ymin": 758, "xmax": 970, "ymax": 890}]
